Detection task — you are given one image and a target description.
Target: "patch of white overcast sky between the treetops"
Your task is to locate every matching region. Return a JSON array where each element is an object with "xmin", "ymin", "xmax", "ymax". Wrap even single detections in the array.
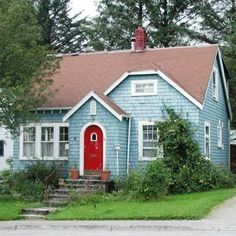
[{"xmin": 71, "ymin": 0, "xmax": 97, "ymax": 17}]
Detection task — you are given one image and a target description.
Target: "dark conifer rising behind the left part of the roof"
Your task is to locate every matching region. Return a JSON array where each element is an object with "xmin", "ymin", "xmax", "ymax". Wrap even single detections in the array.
[{"xmin": 33, "ymin": 0, "xmax": 86, "ymax": 53}]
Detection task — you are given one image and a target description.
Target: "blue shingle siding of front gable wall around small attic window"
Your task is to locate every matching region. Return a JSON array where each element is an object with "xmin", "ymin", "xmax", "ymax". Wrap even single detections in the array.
[{"xmin": 108, "ymin": 75, "xmax": 199, "ymax": 168}]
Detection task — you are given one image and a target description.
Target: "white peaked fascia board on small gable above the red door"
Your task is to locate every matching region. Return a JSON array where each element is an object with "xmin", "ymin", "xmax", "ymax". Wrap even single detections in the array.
[{"xmin": 63, "ymin": 91, "xmax": 125, "ymax": 122}]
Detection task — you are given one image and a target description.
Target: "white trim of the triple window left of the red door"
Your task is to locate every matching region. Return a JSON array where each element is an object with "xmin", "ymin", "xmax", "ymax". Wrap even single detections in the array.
[{"xmin": 19, "ymin": 123, "xmax": 69, "ymax": 160}]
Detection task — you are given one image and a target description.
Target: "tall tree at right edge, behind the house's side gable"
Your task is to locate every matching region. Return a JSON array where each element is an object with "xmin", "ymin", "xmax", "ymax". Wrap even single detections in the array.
[{"xmin": 193, "ymin": 0, "xmax": 236, "ymax": 128}]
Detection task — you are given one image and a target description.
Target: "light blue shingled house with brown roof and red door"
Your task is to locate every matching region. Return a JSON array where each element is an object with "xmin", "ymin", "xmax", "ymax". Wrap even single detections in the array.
[{"xmin": 13, "ymin": 39, "xmax": 231, "ymax": 177}]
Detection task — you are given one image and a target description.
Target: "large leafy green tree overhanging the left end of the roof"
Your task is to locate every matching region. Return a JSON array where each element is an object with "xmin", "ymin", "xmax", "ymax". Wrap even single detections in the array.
[{"xmin": 0, "ymin": 0, "xmax": 57, "ymax": 134}]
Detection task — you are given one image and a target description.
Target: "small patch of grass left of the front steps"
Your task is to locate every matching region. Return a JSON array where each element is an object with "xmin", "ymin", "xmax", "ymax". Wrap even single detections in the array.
[{"xmin": 0, "ymin": 199, "xmax": 40, "ymax": 221}]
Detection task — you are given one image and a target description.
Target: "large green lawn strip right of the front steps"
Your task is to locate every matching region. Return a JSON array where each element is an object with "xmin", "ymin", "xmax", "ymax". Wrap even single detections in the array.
[{"xmin": 47, "ymin": 188, "xmax": 236, "ymax": 220}]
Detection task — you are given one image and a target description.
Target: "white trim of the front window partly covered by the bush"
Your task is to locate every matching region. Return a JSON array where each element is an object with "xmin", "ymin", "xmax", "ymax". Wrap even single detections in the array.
[{"xmin": 138, "ymin": 121, "xmax": 163, "ymax": 161}]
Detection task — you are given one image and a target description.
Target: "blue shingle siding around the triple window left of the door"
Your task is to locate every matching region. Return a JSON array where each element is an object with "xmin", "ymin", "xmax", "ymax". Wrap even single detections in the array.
[{"xmin": 13, "ymin": 110, "xmax": 68, "ymax": 170}]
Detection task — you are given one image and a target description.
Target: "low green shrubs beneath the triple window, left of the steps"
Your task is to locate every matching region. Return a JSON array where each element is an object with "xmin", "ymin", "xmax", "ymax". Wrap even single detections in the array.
[{"xmin": 0, "ymin": 161, "xmax": 62, "ymax": 201}]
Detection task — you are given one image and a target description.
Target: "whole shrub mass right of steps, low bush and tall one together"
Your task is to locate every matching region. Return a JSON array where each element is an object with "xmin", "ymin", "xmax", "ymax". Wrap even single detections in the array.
[{"xmin": 125, "ymin": 109, "xmax": 236, "ymax": 199}]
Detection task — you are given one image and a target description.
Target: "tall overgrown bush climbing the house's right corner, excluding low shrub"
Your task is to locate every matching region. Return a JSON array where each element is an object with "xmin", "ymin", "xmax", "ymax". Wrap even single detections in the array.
[{"xmin": 156, "ymin": 109, "xmax": 235, "ymax": 193}]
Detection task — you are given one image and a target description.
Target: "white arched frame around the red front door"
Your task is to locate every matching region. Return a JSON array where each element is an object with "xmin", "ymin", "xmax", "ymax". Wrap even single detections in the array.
[{"xmin": 80, "ymin": 122, "xmax": 106, "ymax": 175}]
